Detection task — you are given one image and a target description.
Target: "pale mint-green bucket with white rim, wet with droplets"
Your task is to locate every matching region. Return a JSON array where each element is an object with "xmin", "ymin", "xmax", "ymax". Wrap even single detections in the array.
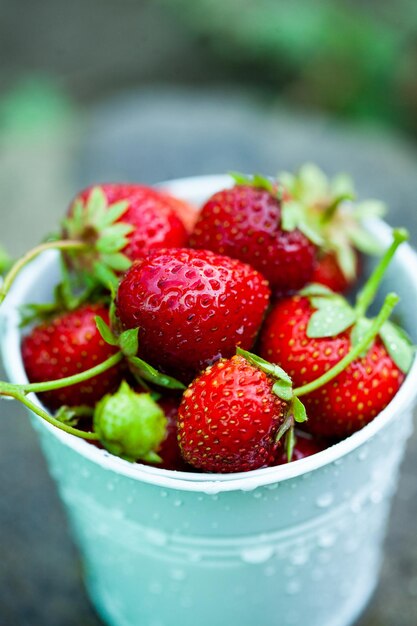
[{"xmin": 1, "ymin": 178, "xmax": 417, "ymax": 626}]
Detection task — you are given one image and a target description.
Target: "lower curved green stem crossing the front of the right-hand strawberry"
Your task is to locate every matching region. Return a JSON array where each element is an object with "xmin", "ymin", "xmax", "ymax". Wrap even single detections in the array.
[{"xmin": 294, "ymin": 293, "xmax": 399, "ymax": 397}]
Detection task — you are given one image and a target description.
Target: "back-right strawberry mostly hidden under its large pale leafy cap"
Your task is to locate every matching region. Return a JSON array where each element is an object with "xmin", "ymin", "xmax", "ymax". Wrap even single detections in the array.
[{"xmin": 278, "ymin": 163, "xmax": 385, "ymax": 293}]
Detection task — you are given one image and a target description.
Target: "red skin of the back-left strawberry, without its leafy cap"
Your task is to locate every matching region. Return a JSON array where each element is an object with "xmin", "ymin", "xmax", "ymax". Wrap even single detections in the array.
[{"xmin": 69, "ymin": 183, "xmax": 188, "ymax": 261}]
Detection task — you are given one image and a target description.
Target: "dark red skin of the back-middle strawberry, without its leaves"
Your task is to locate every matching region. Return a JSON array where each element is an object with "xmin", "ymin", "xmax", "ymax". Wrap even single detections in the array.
[{"xmin": 190, "ymin": 185, "xmax": 316, "ymax": 294}]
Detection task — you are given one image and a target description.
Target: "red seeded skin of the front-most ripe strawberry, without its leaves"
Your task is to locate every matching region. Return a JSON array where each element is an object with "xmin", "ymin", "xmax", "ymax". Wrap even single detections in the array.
[{"xmin": 178, "ymin": 356, "xmax": 285, "ymax": 473}]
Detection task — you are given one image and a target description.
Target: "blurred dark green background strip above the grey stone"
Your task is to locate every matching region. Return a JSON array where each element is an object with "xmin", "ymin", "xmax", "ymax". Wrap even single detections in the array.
[{"xmin": 0, "ymin": 0, "xmax": 417, "ymax": 131}]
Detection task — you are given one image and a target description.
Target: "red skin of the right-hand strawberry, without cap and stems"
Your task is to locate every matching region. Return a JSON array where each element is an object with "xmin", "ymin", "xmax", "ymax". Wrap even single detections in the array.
[{"xmin": 260, "ymin": 296, "xmax": 404, "ymax": 438}]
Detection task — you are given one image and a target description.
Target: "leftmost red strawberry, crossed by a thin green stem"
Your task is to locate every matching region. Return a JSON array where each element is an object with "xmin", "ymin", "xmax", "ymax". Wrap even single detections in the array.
[{"xmin": 22, "ymin": 304, "xmax": 123, "ymax": 409}]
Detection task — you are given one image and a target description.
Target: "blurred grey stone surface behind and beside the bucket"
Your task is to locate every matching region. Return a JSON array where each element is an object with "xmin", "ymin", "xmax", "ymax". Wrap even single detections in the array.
[{"xmin": 0, "ymin": 89, "xmax": 417, "ymax": 626}]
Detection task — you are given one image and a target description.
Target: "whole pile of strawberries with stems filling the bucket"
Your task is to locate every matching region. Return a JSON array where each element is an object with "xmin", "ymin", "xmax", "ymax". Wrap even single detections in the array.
[{"xmin": 6, "ymin": 165, "xmax": 413, "ymax": 472}]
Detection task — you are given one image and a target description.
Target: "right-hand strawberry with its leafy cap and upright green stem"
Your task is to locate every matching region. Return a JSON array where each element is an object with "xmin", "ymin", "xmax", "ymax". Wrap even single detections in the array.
[{"xmin": 260, "ymin": 230, "xmax": 413, "ymax": 437}]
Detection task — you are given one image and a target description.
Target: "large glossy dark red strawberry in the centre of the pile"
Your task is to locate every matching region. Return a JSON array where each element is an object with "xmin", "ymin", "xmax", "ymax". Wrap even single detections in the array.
[{"xmin": 116, "ymin": 248, "xmax": 269, "ymax": 382}]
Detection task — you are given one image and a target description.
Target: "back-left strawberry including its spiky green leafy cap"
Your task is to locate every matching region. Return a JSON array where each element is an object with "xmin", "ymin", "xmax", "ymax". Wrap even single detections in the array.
[{"xmin": 63, "ymin": 183, "xmax": 188, "ymax": 284}]
